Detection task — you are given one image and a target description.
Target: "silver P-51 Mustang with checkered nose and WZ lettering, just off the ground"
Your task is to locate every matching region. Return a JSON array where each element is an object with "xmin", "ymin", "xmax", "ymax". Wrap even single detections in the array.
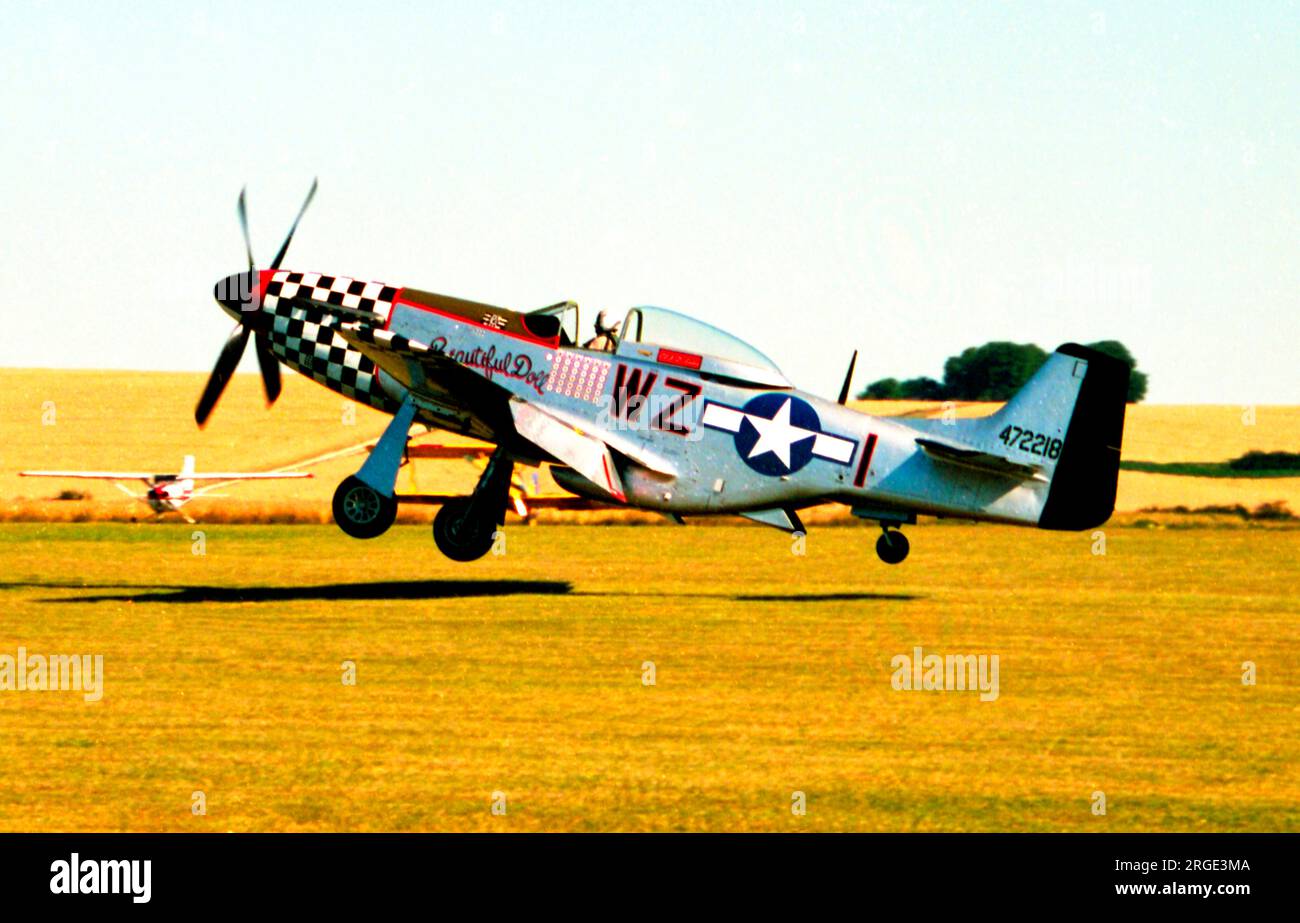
[{"xmin": 195, "ymin": 183, "xmax": 1128, "ymax": 564}]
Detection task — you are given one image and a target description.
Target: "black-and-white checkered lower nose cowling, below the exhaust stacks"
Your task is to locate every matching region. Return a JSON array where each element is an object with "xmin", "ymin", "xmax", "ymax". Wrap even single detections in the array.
[{"xmin": 263, "ymin": 273, "xmax": 398, "ymax": 413}]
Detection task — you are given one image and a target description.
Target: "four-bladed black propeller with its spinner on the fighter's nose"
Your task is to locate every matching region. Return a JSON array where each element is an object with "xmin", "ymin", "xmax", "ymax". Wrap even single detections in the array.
[{"xmin": 194, "ymin": 179, "xmax": 317, "ymax": 426}]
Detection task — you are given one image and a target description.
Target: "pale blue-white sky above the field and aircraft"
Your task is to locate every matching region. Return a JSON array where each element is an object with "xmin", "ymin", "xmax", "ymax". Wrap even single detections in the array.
[{"xmin": 0, "ymin": 0, "xmax": 1300, "ymax": 404}]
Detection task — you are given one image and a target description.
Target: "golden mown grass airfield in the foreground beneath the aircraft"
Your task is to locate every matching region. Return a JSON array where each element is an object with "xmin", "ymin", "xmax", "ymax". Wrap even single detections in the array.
[{"xmin": 0, "ymin": 524, "xmax": 1300, "ymax": 831}]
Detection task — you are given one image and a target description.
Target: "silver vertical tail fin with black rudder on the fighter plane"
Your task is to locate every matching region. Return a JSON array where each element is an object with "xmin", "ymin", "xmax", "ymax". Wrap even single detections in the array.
[{"xmin": 989, "ymin": 343, "xmax": 1128, "ymax": 530}]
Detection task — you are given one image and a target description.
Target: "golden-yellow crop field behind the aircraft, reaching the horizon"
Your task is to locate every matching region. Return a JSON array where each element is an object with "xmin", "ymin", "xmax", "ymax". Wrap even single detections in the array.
[{"xmin": 0, "ymin": 369, "xmax": 1300, "ymax": 521}]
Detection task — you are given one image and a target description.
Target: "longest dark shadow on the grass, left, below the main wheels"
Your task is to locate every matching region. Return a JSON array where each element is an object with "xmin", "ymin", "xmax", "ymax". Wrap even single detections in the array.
[{"xmin": 16, "ymin": 580, "xmax": 573, "ymax": 605}]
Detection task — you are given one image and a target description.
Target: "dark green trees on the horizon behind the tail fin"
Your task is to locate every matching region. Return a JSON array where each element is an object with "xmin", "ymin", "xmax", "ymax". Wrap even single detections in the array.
[{"xmin": 858, "ymin": 339, "xmax": 1147, "ymax": 403}]
